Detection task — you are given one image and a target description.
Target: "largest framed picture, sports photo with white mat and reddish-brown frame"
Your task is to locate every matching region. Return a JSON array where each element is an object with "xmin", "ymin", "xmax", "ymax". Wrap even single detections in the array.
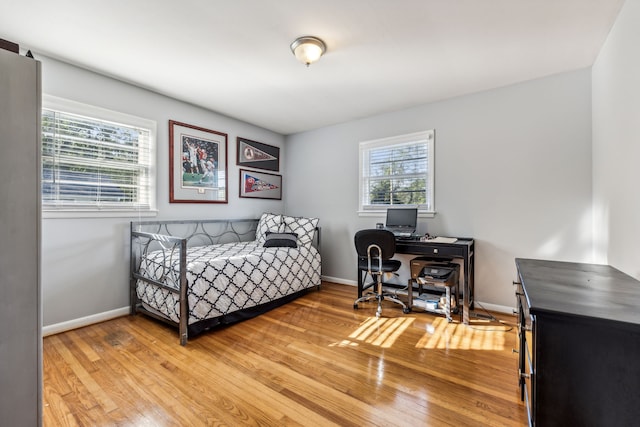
[{"xmin": 169, "ymin": 120, "xmax": 228, "ymax": 203}]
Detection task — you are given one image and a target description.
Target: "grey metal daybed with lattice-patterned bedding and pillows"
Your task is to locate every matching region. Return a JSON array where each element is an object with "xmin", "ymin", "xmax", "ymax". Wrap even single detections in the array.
[{"xmin": 130, "ymin": 214, "xmax": 321, "ymax": 345}]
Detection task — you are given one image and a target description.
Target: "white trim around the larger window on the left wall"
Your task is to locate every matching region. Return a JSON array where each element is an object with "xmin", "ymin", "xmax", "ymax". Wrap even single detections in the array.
[{"xmin": 42, "ymin": 94, "xmax": 158, "ymax": 218}]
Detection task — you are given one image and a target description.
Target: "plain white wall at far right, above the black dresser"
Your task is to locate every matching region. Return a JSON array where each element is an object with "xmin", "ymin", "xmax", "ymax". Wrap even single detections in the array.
[{"xmin": 593, "ymin": 0, "xmax": 640, "ymax": 279}]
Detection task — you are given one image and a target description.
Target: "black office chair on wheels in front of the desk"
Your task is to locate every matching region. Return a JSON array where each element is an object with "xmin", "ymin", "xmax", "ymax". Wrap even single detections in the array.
[{"xmin": 353, "ymin": 229, "xmax": 411, "ymax": 317}]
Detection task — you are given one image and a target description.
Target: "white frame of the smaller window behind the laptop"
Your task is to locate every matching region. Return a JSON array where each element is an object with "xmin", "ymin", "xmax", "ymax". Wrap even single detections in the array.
[{"xmin": 358, "ymin": 129, "xmax": 436, "ymax": 217}]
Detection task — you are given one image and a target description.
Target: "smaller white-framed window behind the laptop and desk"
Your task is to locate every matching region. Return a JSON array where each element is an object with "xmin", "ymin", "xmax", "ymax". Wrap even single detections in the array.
[{"xmin": 360, "ymin": 130, "xmax": 434, "ymax": 213}]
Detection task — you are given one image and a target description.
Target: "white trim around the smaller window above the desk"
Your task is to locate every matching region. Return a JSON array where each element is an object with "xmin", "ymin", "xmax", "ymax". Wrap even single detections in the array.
[{"xmin": 358, "ymin": 129, "xmax": 436, "ymax": 218}]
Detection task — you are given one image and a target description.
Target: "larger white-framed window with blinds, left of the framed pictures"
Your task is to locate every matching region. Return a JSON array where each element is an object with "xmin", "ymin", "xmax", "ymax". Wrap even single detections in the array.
[{"xmin": 42, "ymin": 96, "xmax": 156, "ymax": 216}]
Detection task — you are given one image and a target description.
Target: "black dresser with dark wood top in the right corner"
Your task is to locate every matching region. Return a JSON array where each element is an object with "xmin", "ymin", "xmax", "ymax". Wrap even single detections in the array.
[{"xmin": 515, "ymin": 258, "xmax": 640, "ymax": 427}]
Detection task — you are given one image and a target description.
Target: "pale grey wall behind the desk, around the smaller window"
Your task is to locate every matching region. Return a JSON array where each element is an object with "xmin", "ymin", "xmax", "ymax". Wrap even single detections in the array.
[{"xmin": 284, "ymin": 69, "xmax": 592, "ymax": 306}]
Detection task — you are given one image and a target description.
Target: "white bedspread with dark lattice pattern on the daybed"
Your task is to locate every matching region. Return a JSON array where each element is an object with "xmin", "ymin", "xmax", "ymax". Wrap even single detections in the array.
[{"xmin": 136, "ymin": 241, "xmax": 321, "ymax": 325}]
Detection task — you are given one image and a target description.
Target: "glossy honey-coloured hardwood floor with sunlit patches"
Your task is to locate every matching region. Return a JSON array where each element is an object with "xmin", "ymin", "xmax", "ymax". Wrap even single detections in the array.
[{"xmin": 43, "ymin": 283, "xmax": 526, "ymax": 426}]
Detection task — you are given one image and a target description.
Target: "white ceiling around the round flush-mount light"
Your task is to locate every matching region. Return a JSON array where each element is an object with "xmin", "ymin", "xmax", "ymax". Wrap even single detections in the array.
[{"xmin": 0, "ymin": 0, "xmax": 624, "ymax": 134}]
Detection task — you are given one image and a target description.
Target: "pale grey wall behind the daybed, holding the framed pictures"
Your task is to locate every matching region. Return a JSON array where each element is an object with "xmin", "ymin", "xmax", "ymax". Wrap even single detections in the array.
[{"xmin": 40, "ymin": 52, "xmax": 284, "ymax": 327}]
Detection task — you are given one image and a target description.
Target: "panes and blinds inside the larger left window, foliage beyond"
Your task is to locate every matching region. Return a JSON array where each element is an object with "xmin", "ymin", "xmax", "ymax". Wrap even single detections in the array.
[{"xmin": 42, "ymin": 110, "xmax": 148, "ymax": 205}]
